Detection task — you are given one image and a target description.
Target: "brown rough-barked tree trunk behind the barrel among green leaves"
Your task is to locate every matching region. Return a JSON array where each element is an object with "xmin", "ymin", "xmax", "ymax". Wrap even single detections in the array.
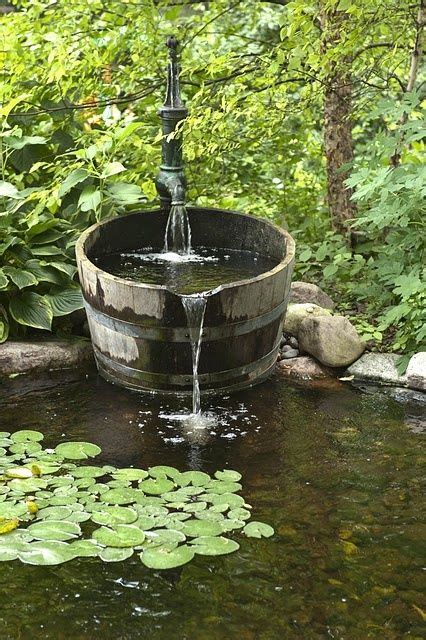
[{"xmin": 321, "ymin": 10, "xmax": 356, "ymax": 236}]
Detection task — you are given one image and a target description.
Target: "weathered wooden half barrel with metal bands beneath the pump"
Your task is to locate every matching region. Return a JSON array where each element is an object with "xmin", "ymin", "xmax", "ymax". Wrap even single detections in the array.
[{"xmin": 76, "ymin": 208, "xmax": 295, "ymax": 393}]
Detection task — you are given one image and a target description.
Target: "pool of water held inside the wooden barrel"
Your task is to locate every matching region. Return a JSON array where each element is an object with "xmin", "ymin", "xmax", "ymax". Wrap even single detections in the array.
[{"xmin": 94, "ymin": 247, "xmax": 278, "ymax": 295}]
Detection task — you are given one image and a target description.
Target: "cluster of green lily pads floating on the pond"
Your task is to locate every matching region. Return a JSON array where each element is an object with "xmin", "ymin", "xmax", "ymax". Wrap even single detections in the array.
[{"xmin": 0, "ymin": 429, "xmax": 274, "ymax": 569}]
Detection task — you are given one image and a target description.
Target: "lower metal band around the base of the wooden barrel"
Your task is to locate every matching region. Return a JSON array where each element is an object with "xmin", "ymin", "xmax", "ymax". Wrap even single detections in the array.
[{"xmin": 93, "ymin": 343, "xmax": 279, "ymax": 389}]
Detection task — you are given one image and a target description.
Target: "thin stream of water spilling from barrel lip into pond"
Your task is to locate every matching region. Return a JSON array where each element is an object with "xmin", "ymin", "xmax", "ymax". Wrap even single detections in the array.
[{"xmin": 181, "ymin": 294, "xmax": 207, "ymax": 416}]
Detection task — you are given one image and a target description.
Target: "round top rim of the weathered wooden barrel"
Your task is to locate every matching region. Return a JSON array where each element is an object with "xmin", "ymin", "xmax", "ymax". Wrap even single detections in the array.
[{"xmin": 75, "ymin": 207, "xmax": 296, "ymax": 298}]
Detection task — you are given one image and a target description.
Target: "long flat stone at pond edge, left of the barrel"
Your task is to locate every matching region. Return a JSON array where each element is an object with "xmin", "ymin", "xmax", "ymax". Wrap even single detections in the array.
[{"xmin": 0, "ymin": 340, "xmax": 93, "ymax": 376}]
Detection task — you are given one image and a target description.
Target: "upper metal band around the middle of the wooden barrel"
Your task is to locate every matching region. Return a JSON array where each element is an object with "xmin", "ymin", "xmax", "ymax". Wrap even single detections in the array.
[{"xmin": 84, "ymin": 296, "xmax": 287, "ymax": 342}]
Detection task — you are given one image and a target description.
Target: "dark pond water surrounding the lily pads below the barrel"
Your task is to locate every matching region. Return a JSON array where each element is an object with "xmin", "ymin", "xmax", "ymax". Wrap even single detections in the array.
[{"xmin": 0, "ymin": 373, "xmax": 426, "ymax": 640}]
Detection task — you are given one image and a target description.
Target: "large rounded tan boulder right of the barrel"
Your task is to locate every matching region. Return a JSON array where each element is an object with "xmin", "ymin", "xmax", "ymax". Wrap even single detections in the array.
[{"xmin": 298, "ymin": 316, "xmax": 365, "ymax": 367}]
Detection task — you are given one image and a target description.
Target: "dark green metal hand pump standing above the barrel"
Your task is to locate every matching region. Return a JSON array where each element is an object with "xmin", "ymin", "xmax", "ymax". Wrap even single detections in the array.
[{"xmin": 155, "ymin": 36, "xmax": 188, "ymax": 212}]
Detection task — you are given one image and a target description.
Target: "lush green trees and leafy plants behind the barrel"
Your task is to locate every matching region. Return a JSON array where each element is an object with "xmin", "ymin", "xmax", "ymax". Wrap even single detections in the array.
[{"xmin": 0, "ymin": 0, "xmax": 426, "ymax": 364}]
